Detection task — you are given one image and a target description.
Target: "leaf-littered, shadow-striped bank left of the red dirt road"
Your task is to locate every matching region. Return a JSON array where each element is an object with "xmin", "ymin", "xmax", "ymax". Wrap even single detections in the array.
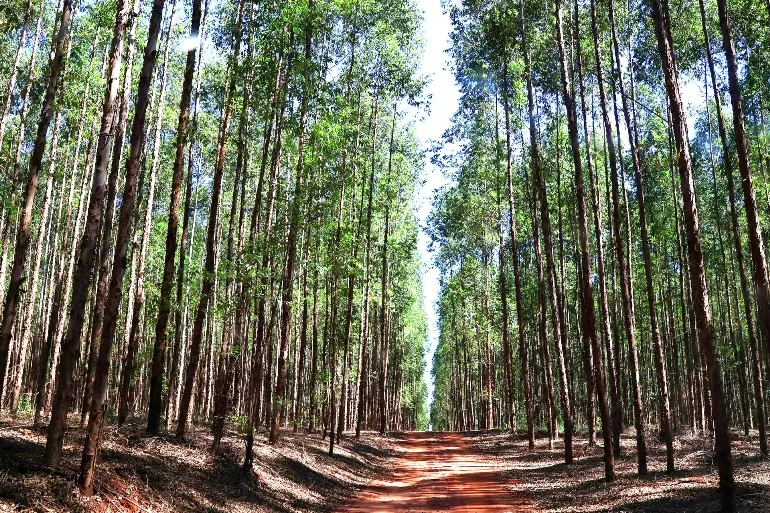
[{"xmin": 0, "ymin": 416, "xmax": 392, "ymax": 513}]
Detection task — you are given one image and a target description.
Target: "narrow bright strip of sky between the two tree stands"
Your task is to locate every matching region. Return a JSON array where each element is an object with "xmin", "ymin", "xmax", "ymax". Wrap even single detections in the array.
[{"xmin": 415, "ymin": 0, "xmax": 460, "ymax": 410}]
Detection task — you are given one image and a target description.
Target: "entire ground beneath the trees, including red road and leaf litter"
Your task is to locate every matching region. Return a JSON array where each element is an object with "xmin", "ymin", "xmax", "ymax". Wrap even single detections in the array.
[{"xmin": 0, "ymin": 418, "xmax": 770, "ymax": 513}]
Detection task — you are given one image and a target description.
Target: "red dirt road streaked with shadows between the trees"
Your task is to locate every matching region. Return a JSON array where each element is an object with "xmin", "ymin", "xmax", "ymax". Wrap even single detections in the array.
[{"xmin": 340, "ymin": 433, "xmax": 533, "ymax": 513}]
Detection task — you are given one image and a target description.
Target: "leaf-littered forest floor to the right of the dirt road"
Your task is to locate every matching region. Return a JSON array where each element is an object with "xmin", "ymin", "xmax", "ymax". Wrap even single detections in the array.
[{"xmin": 467, "ymin": 430, "xmax": 770, "ymax": 513}]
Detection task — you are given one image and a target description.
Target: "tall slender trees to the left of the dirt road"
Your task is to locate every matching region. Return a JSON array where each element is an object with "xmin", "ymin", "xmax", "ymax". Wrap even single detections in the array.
[{"xmin": 0, "ymin": 0, "xmax": 427, "ymax": 495}]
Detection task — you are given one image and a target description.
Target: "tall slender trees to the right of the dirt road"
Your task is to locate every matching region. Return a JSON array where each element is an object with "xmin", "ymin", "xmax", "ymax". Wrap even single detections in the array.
[{"xmin": 428, "ymin": 0, "xmax": 770, "ymax": 511}]
